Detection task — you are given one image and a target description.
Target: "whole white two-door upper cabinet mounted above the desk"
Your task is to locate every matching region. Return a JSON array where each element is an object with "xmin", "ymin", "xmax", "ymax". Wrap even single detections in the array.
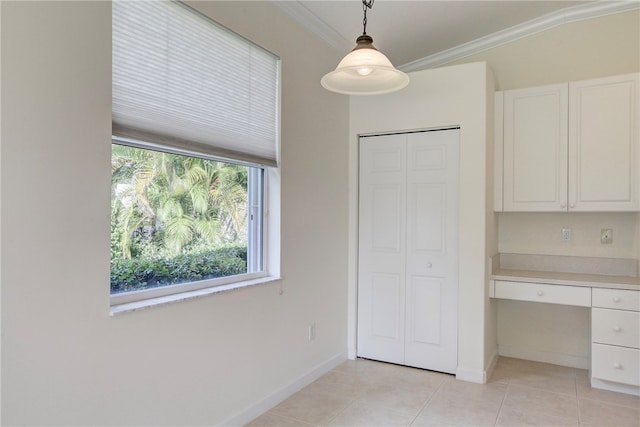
[{"xmin": 495, "ymin": 74, "xmax": 640, "ymax": 212}]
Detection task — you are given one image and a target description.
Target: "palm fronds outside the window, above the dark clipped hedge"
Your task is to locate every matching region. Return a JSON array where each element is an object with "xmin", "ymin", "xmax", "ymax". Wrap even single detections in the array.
[{"xmin": 112, "ymin": 144, "xmax": 247, "ymax": 258}]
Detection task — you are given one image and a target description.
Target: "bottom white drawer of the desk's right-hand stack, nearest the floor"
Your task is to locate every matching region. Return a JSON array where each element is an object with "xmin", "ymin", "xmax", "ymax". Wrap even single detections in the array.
[{"xmin": 591, "ymin": 344, "xmax": 640, "ymax": 386}]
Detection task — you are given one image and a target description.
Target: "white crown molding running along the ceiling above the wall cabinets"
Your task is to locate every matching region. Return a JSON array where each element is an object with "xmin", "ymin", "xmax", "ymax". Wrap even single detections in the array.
[{"xmin": 398, "ymin": 0, "xmax": 640, "ymax": 72}]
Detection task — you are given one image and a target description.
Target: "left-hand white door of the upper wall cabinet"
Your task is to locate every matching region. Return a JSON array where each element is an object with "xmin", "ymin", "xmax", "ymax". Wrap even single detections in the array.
[{"xmin": 503, "ymin": 84, "xmax": 568, "ymax": 212}]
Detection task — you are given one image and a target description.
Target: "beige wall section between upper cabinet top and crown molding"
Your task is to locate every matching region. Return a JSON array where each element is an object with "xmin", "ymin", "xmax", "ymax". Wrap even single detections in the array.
[{"xmin": 450, "ymin": 10, "xmax": 640, "ymax": 90}]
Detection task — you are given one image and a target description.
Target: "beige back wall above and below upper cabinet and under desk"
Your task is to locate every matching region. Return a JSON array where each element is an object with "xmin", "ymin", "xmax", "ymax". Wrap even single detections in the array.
[{"xmin": 452, "ymin": 10, "xmax": 640, "ymax": 366}]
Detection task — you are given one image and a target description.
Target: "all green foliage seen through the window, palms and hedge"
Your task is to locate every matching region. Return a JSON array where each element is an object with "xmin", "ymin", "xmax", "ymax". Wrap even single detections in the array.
[{"xmin": 111, "ymin": 144, "xmax": 248, "ymax": 293}]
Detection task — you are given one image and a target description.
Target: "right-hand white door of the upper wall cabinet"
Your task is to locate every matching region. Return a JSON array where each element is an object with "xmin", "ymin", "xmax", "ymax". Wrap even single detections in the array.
[{"xmin": 569, "ymin": 74, "xmax": 640, "ymax": 211}]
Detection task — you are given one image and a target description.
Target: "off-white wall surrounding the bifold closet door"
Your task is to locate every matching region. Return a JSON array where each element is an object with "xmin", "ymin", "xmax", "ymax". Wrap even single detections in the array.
[{"xmin": 349, "ymin": 63, "xmax": 497, "ymax": 382}]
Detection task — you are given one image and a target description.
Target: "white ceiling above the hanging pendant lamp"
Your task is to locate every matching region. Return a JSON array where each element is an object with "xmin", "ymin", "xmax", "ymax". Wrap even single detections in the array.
[{"xmin": 274, "ymin": 0, "xmax": 640, "ymax": 71}]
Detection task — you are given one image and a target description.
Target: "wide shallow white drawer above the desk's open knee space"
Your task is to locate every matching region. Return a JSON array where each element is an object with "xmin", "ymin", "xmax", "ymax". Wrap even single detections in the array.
[{"xmin": 495, "ymin": 280, "xmax": 591, "ymax": 307}]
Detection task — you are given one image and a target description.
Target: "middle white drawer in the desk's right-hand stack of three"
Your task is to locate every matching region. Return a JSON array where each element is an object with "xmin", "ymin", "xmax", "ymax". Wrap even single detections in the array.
[{"xmin": 591, "ymin": 308, "xmax": 640, "ymax": 348}]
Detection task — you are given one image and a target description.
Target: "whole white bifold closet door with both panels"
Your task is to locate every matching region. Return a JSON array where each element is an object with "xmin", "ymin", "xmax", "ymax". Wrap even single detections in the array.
[{"xmin": 358, "ymin": 129, "xmax": 459, "ymax": 373}]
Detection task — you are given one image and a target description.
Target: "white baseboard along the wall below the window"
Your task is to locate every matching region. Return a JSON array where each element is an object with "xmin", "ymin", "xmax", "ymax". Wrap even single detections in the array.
[{"xmin": 218, "ymin": 352, "xmax": 347, "ymax": 427}]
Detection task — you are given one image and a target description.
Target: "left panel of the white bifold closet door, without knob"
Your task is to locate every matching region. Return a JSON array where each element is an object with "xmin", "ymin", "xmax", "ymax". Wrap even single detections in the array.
[{"xmin": 358, "ymin": 135, "xmax": 406, "ymax": 363}]
